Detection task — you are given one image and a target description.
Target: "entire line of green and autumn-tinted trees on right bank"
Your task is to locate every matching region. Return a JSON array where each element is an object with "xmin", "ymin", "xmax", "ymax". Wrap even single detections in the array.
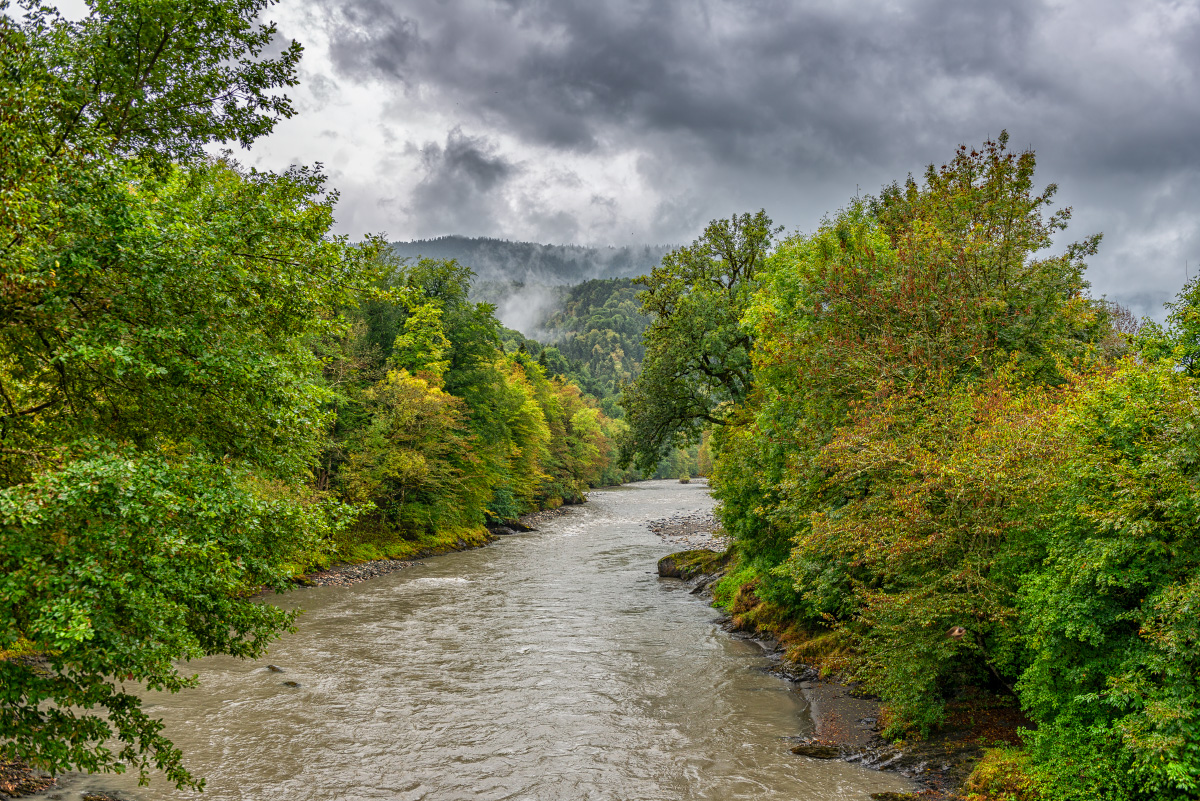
[{"xmin": 625, "ymin": 135, "xmax": 1200, "ymax": 800}]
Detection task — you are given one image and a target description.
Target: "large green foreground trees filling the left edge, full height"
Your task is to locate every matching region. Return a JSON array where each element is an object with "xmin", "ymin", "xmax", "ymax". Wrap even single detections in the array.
[{"xmin": 0, "ymin": 0, "xmax": 380, "ymax": 787}]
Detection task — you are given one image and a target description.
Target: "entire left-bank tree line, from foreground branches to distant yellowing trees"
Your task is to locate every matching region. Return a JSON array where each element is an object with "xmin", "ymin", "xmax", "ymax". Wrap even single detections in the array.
[{"xmin": 0, "ymin": 0, "xmax": 619, "ymax": 787}]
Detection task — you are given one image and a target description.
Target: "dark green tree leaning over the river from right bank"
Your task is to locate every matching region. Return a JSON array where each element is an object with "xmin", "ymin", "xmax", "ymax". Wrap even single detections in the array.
[{"xmin": 622, "ymin": 211, "xmax": 779, "ymax": 470}]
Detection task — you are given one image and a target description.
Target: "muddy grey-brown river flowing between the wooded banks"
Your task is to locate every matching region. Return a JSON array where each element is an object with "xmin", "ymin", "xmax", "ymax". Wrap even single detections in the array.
[{"xmin": 49, "ymin": 481, "xmax": 908, "ymax": 801}]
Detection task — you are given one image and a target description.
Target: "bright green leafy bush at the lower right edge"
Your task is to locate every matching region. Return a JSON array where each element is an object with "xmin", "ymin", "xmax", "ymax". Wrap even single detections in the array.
[{"xmin": 1020, "ymin": 362, "xmax": 1200, "ymax": 799}]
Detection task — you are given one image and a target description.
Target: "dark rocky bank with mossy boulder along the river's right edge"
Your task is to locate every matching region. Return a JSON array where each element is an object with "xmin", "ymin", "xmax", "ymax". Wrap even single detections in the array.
[{"xmin": 650, "ymin": 513, "xmax": 1028, "ymax": 801}]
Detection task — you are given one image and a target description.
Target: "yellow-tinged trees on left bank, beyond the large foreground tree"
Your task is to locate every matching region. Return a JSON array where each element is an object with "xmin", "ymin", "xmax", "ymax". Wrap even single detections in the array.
[{"xmin": 320, "ymin": 259, "xmax": 620, "ymax": 540}]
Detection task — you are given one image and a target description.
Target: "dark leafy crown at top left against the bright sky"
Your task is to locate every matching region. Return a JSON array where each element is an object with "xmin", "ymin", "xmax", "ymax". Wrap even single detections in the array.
[{"xmin": 13, "ymin": 0, "xmax": 302, "ymax": 167}]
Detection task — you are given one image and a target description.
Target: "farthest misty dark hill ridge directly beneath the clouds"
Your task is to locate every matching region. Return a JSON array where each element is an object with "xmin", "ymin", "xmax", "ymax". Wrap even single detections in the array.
[{"xmin": 391, "ymin": 236, "xmax": 673, "ymax": 287}]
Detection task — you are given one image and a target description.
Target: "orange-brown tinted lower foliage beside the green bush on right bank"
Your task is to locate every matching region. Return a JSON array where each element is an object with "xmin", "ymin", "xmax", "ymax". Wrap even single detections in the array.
[{"xmin": 806, "ymin": 380, "xmax": 1058, "ymax": 730}]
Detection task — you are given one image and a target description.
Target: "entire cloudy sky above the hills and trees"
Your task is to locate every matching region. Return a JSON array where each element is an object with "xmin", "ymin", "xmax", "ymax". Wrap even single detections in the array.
[{"xmin": 231, "ymin": 0, "xmax": 1200, "ymax": 315}]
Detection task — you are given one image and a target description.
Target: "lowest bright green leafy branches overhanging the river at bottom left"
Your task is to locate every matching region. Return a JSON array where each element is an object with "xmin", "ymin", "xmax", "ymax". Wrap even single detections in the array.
[{"xmin": 0, "ymin": 444, "xmax": 344, "ymax": 787}]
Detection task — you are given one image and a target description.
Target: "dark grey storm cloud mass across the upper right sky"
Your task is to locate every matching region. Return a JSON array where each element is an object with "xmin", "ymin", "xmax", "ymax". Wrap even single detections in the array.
[{"xmin": 314, "ymin": 0, "xmax": 1200, "ymax": 314}]
